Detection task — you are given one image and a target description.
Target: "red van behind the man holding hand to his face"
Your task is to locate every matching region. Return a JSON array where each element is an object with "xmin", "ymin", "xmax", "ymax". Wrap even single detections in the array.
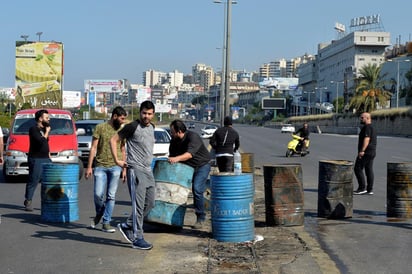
[{"xmin": 3, "ymin": 109, "xmax": 83, "ymax": 181}]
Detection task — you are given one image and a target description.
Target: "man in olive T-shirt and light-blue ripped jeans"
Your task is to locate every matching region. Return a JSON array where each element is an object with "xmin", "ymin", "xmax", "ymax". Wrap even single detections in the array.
[{"xmin": 85, "ymin": 107, "xmax": 127, "ymax": 233}]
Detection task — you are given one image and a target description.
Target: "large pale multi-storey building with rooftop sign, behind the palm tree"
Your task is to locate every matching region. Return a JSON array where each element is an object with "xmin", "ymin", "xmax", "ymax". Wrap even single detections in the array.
[{"xmin": 298, "ymin": 31, "xmax": 390, "ymax": 110}]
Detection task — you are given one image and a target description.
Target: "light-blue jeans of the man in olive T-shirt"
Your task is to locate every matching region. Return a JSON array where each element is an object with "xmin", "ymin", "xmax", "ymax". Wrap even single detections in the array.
[{"xmin": 93, "ymin": 166, "xmax": 122, "ymax": 224}]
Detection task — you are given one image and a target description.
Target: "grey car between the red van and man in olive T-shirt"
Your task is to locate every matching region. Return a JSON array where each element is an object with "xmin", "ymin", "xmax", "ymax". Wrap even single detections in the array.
[{"xmin": 76, "ymin": 120, "xmax": 104, "ymax": 166}]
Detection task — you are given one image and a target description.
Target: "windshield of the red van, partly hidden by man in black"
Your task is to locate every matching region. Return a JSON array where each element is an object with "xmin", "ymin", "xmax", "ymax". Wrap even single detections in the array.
[{"xmin": 12, "ymin": 116, "xmax": 74, "ymax": 135}]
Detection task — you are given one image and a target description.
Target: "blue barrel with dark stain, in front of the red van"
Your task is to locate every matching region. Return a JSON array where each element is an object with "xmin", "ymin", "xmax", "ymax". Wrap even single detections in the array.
[{"xmin": 41, "ymin": 164, "xmax": 79, "ymax": 223}]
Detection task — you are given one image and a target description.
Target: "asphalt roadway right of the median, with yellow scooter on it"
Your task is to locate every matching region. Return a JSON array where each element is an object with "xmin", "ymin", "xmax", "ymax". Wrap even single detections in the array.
[{"xmin": 235, "ymin": 125, "xmax": 412, "ymax": 273}]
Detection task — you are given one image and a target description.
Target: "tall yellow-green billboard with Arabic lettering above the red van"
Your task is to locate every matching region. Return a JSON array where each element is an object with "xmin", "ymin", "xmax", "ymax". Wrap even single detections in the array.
[{"xmin": 15, "ymin": 41, "xmax": 63, "ymax": 109}]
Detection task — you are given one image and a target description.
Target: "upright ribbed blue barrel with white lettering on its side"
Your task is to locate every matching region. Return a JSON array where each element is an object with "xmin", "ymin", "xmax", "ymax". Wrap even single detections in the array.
[{"xmin": 210, "ymin": 173, "xmax": 255, "ymax": 242}]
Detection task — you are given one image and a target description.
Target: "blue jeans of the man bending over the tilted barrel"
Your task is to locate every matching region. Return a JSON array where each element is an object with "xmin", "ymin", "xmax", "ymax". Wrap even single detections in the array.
[{"xmin": 192, "ymin": 163, "xmax": 210, "ymax": 221}]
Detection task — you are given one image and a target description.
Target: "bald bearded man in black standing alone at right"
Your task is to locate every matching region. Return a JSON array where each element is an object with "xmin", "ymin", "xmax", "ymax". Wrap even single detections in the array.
[{"xmin": 353, "ymin": 112, "xmax": 377, "ymax": 195}]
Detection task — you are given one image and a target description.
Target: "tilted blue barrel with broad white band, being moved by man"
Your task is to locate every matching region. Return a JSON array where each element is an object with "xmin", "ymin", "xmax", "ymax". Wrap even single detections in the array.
[{"xmin": 146, "ymin": 159, "xmax": 194, "ymax": 227}]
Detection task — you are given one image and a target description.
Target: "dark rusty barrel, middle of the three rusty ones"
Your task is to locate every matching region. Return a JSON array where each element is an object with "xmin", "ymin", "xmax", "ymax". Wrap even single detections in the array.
[{"xmin": 318, "ymin": 160, "xmax": 353, "ymax": 219}]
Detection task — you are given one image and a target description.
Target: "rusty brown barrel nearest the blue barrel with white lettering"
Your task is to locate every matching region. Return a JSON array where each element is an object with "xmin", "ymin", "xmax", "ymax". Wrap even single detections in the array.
[{"xmin": 263, "ymin": 164, "xmax": 304, "ymax": 226}]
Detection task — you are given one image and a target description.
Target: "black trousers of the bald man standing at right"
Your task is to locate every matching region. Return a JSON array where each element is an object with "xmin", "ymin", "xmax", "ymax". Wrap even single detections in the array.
[{"xmin": 354, "ymin": 154, "xmax": 375, "ymax": 192}]
